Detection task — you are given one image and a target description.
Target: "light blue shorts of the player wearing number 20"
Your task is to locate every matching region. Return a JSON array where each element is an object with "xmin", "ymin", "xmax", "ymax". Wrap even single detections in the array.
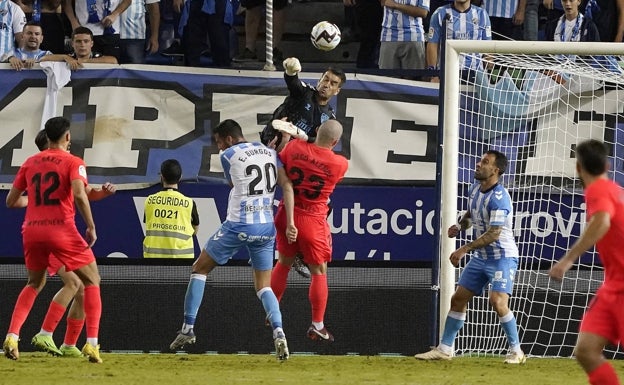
[{"xmin": 204, "ymin": 221, "xmax": 275, "ymax": 270}]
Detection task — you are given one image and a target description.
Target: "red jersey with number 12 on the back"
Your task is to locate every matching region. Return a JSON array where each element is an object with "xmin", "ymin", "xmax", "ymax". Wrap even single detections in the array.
[{"xmin": 13, "ymin": 149, "xmax": 87, "ymax": 228}]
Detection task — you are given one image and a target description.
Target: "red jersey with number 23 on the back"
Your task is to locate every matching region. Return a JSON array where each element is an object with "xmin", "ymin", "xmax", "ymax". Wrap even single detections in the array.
[{"xmin": 279, "ymin": 139, "xmax": 349, "ymax": 218}]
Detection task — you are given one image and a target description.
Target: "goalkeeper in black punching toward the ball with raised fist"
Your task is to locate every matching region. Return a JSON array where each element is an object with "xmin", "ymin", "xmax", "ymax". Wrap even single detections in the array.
[{"xmin": 260, "ymin": 57, "xmax": 347, "ymax": 152}]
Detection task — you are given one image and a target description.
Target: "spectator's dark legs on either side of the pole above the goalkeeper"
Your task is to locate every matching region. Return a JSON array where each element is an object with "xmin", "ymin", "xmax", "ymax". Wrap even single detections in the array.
[{"xmin": 233, "ymin": 0, "xmax": 288, "ymax": 64}]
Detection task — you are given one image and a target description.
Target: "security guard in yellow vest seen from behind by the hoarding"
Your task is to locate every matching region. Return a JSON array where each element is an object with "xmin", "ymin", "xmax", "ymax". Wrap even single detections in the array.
[{"xmin": 143, "ymin": 159, "xmax": 199, "ymax": 258}]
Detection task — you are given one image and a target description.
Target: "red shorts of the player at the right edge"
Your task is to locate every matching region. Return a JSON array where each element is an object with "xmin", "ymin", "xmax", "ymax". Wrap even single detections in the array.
[{"xmin": 579, "ymin": 290, "xmax": 624, "ymax": 345}]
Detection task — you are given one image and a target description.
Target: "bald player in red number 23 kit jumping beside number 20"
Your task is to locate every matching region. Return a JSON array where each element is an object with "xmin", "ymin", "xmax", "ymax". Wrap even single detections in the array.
[{"xmin": 271, "ymin": 119, "xmax": 349, "ymax": 341}]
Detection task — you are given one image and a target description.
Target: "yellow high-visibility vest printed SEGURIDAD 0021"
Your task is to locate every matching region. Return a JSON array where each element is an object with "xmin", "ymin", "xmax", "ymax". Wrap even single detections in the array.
[{"xmin": 143, "ymin": 189, "xmax": 195, "ymax": 258}]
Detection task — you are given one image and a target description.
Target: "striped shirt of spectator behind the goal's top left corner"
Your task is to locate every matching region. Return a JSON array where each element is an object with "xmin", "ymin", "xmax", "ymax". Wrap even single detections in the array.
[{"xmin": 428, "ymin": 4, "xmax": 492, "ymax": 69}]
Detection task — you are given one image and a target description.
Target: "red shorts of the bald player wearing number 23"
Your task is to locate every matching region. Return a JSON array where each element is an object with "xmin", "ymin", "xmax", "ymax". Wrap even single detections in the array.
[{"xmin": 275, "ymin": 206, "xmax": 332, "ymax": 265}]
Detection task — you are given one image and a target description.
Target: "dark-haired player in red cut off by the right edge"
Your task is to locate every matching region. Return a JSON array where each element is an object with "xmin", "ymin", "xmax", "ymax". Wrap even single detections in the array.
[{"xmin": 549, "ymin": 139, "xmax": 624, "ymax": 385}]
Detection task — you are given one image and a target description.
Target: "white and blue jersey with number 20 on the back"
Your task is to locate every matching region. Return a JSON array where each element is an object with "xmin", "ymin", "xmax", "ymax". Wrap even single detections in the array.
[{"xmin": 221, "ymin": 142, "xmax": 282, "ymax": 224}]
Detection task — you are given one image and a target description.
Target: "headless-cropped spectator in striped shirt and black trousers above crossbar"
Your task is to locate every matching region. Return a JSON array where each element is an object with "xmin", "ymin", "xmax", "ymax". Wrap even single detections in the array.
[{"xmin": 482, "ymin": 0, "xmax": 527, "ymax": 40}]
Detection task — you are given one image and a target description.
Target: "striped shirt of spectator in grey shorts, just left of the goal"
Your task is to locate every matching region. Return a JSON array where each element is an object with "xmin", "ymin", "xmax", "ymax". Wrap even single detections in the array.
[{"xmin": 380, "ymin": 0, "xmax": 429, "ymax": 41}]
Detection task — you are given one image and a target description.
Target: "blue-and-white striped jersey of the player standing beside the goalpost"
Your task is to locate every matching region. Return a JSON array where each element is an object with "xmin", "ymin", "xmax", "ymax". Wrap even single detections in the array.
[{"xmin": 468, "ymin": 183, "xmax": 519, "ymax": 259}]
